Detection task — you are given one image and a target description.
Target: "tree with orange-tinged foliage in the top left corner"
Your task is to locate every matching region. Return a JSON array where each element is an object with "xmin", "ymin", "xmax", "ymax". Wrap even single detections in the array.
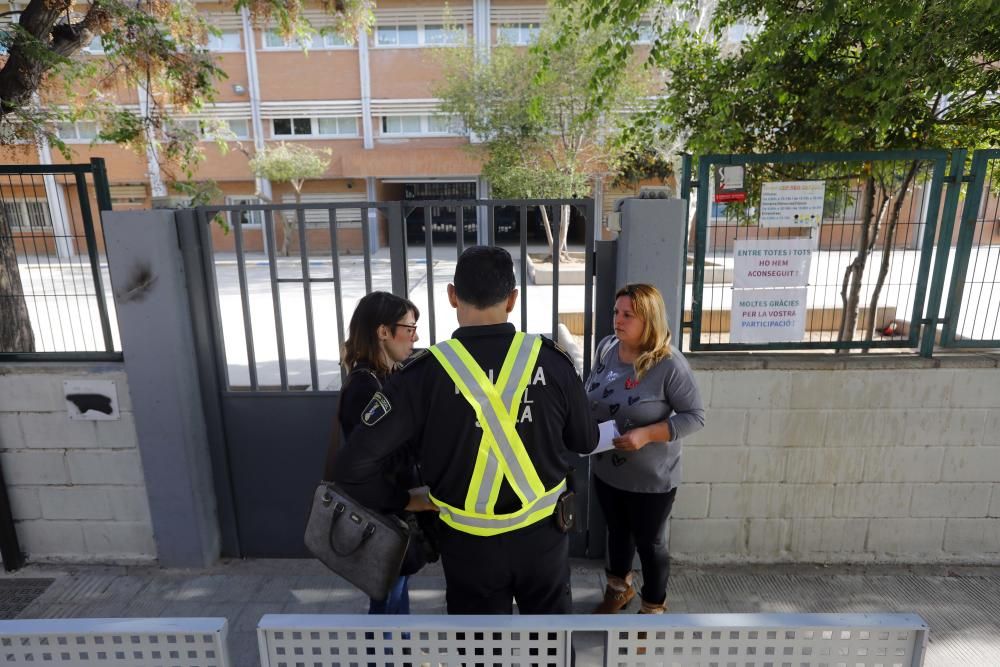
[{"xmin": 0, "ymin": 0, "xmax": 374, "ymax": 352}]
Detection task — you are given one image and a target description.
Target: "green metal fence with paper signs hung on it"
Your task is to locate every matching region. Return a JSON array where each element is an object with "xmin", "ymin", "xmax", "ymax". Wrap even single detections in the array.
[{"xmin": 691, "ymin": 150, "xmax": 1000, "ymax": 356}]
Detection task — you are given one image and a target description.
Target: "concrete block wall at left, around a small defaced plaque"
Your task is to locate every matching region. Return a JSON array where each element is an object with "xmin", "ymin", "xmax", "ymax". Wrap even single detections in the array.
[{"xmin": 0, "ymin": 363, "xmax": 156, "ymax": 562}]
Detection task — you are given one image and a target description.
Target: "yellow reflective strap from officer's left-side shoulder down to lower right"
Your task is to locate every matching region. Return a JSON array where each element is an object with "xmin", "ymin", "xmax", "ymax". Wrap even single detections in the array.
[{"xmin": 436, "ymin": 340, "xmax": 545, "ymax": 503}]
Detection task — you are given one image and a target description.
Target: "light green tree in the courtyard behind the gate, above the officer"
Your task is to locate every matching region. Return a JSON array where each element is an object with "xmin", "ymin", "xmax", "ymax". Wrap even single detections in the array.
[{"xmin": 436, "ymin": 12, "xmax": 656, "ymax": 261}]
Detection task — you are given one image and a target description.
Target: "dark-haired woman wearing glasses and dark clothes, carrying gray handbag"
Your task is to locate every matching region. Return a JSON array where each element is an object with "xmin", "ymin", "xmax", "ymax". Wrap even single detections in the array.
[{"xmin": 324, "ymin": 292, "xmax": 423, "ymax": 614}]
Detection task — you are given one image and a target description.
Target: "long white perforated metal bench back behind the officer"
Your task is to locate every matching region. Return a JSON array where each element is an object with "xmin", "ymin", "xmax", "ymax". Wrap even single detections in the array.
[{"xmin": 258, "ymin": 614, "xmax": 927, "ymax": 667}]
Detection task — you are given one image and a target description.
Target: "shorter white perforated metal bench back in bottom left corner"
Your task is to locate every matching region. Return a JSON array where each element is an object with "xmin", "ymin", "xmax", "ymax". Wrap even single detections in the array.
[{"xmin": 0, "ymin": 618, "xmax": 229, "ymax": 667}]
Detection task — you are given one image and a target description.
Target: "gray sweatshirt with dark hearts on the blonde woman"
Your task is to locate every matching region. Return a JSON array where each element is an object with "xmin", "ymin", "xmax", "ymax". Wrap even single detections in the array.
[{"xmin": 586, "ymin": 336, "xmax": 705, "ymax": 493}]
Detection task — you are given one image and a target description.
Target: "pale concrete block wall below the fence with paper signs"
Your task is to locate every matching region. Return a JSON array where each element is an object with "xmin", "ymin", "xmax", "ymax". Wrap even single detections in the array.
[{"xmin": 670, "ymin": 355, "xmax": 1000, "ymax": 562}]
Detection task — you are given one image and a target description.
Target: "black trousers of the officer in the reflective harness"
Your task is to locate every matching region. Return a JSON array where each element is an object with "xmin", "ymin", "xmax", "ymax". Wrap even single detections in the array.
[{"xmin": 441, "ymin": 517, "xmax": 573, "ymax": 614}]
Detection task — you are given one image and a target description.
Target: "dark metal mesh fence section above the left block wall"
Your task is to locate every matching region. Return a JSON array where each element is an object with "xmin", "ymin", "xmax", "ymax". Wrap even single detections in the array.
[{"xmin": 0, "ymin": 158, "xmax": 121, "ymax": 361}]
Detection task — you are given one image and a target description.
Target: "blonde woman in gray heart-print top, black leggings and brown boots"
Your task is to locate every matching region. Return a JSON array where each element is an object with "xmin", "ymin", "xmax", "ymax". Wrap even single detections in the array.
[{"xmin": 587, "ymin": 283, "xmax": 705, "ymax": 614}]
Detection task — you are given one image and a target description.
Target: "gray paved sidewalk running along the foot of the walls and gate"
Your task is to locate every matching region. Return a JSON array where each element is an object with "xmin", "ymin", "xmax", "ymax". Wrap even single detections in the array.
[{"xmin": 0, "ymin": 560, "xmax": 1000, "ymax": 667}]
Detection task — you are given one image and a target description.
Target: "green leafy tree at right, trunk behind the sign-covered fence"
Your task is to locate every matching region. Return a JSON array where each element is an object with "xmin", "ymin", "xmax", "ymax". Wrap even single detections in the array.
[{"xmin": 575, "ymin": 0, "xmax": 1000, "ymax": 340}]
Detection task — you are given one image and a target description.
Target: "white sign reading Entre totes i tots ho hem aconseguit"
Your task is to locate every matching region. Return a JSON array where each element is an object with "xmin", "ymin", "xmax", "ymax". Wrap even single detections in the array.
[{"xmin": 733, "ymin": 239, "xmax": 813, "ymax": 287}]
